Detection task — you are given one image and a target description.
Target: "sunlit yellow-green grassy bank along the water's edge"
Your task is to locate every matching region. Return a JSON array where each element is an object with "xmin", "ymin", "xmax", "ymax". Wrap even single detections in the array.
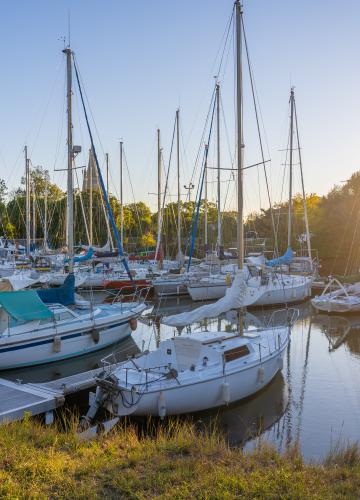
[{"xmin": 0, "ymin": 420, "xmax": 360, "ymax": 498}]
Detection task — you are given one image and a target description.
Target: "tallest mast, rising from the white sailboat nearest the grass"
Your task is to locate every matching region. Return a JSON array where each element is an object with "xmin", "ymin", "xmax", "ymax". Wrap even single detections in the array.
[{"xmin": 235, "ymin": 0, "xmax": 244, "ymax": 269}]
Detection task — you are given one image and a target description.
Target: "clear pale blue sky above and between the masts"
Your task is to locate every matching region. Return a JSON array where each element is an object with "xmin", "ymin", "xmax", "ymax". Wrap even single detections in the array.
[{"xmin": 0, "ymin": 0, "xmax": 360, "ymax": 210}]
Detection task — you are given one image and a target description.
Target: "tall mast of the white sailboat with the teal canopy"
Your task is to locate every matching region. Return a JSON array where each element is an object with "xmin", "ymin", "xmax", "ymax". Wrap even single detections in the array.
[{"xmin": 63, "ymin": 47, "xmax": 74, "ymax": 273}]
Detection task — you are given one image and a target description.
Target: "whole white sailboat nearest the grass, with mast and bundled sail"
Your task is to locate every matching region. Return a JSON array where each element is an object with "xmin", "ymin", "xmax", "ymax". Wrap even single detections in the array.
[{"xmin": 80, "ymin": 0, "xmax": 291, "ymax": 426}]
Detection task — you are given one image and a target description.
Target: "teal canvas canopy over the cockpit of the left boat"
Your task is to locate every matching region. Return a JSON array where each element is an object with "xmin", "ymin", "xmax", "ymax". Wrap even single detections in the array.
[{"xmin": 0, "ymin": 290, "xmax": 53, "ymax": 321}]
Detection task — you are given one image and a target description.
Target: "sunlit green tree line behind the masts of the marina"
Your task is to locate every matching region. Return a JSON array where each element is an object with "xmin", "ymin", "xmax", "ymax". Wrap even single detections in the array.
[{"xmin": 0, "ymin": 167, "xmax": 360, "ymax": 274}]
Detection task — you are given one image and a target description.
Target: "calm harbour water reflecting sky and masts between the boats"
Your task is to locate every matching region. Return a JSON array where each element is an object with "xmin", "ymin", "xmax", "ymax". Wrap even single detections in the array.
[{"xmin": 2, "ymin": 300, "xmax": 360, "ymax": 459}]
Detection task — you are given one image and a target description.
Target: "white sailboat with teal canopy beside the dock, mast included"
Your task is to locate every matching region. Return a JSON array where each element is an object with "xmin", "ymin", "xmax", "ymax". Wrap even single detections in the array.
[{"xmin": 0, "ymin": 47, "xmax": 146, "ymax": 369}]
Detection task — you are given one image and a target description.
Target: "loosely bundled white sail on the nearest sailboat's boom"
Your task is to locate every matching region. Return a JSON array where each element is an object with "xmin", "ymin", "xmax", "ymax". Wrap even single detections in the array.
[{"xmin": 161, "ymin": 271, "xmax": 258, "ymax": 327}]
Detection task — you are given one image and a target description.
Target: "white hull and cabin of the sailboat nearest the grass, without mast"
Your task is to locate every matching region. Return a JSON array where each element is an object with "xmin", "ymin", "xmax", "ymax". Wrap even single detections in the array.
[{"xmin": 85, "ymin": 327, "xmax": 289, "ymax": 422}]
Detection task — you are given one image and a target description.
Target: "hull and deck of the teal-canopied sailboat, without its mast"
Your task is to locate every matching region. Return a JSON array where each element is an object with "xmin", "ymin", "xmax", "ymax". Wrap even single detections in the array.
[{"xmin": 0, "ymin": 290, "xmax": 146, "ymax": 370}]
